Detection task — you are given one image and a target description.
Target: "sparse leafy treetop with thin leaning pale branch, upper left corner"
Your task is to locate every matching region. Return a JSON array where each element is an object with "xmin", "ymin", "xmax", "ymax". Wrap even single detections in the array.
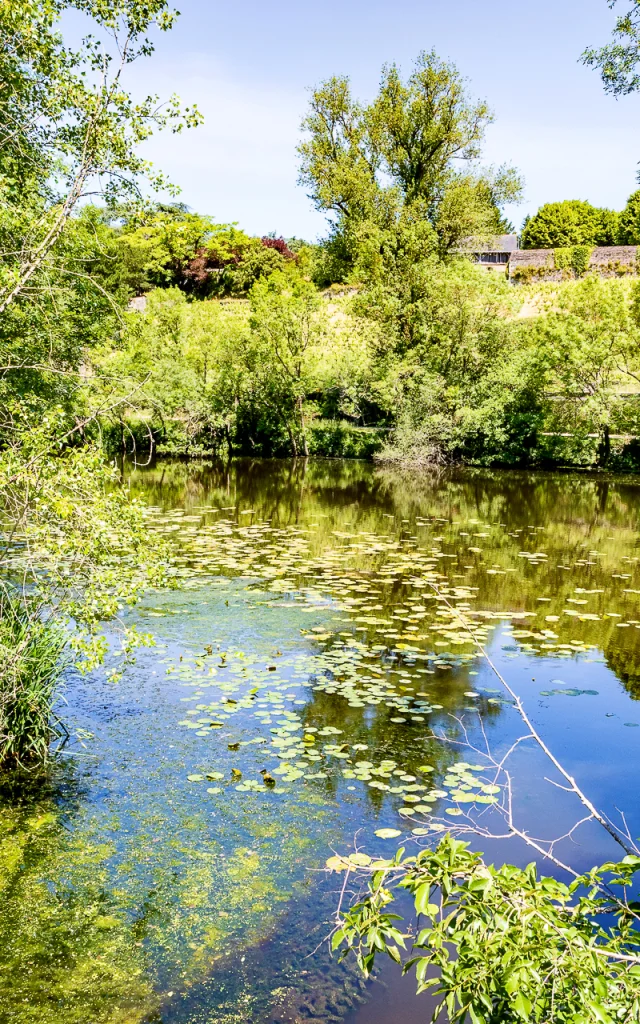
[{"xmin": 0, "ymin": 0, "xmax": 200, "ymax": 313}]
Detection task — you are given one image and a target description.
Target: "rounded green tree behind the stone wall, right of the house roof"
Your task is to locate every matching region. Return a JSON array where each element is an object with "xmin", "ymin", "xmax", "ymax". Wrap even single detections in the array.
[{"xmin": 521, "ymin": 200, "xmax": 617, "ymax": 249}]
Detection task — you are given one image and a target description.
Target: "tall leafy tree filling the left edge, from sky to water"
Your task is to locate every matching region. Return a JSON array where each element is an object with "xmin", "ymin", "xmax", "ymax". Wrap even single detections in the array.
[{"xmin": 0, "ymin": 0, "xmax": 199, "ymax": 765}]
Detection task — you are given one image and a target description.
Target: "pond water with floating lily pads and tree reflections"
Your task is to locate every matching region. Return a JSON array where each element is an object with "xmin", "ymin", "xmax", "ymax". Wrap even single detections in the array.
[{"xmin": 0, "ymin": 460, "xmax": 640, "ymax": 1024}]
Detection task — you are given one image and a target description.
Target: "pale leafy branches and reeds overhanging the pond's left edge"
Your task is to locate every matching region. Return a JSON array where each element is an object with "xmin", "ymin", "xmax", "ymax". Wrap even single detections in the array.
[{"xmin": 0, "ymin": 406, "xmax": 166, "ymax": 762}]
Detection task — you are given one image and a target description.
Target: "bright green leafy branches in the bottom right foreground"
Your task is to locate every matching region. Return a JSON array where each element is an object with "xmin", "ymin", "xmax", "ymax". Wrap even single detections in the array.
[{"xmin": 332, "ymin": 835, "xmax": 640, "ymax": 1024}]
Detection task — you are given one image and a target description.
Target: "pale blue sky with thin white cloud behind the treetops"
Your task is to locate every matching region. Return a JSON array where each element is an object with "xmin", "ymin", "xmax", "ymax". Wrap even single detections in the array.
[{"xmin": 119, "ymin": 0, "xmax": 640, "ymax": 239}]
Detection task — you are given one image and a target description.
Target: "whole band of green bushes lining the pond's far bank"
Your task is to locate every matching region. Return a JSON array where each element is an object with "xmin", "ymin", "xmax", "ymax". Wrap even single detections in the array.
[{"xmin": 91, "ymin": 262, "xmax": 640, "ymax": 466}]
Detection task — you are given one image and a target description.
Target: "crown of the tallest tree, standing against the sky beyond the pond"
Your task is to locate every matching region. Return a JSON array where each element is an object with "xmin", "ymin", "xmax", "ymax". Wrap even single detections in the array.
[{"xmin": 299, "ymin": 52, "xmax": 521, "ymax": 262}]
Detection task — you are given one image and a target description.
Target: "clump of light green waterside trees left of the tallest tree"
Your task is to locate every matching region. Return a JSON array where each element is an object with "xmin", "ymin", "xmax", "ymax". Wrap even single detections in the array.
[{"xmin": 94, "ymin": 269, "xmax": 368, "ymax": 455}]
